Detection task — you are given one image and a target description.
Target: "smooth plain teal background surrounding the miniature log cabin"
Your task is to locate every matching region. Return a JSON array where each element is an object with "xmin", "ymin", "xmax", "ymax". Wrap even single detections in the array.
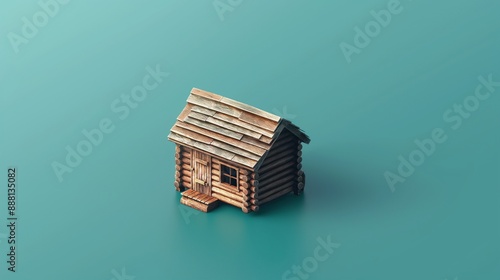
[{"xmin": 0, "ymin": 0, "xmax": 500, "ymax": 280}]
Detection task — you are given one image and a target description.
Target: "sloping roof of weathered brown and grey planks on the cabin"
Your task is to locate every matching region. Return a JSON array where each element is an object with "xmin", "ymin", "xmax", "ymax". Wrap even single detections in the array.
[{"xmin": 168, "ymin": 88, "xmax": 310, "ymax": 169}]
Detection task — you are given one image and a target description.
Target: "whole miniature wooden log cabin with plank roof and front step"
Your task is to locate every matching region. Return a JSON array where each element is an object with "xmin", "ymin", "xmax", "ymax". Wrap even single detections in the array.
[{"xmin": 168, "ymin": 88, "xmax": 310, "ymax": 213}]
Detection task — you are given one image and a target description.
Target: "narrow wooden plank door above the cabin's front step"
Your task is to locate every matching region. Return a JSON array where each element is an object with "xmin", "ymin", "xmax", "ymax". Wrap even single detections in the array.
[{"xmin": 191, "ymin": 151, "xmax": 212, "ymax": 195}]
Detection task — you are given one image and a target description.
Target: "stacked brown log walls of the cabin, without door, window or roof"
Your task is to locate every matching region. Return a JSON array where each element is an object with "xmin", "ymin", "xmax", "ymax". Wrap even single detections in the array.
[{"xmin": 174, "ymin": 138, "xmax": 305, "ymax": 213}]
